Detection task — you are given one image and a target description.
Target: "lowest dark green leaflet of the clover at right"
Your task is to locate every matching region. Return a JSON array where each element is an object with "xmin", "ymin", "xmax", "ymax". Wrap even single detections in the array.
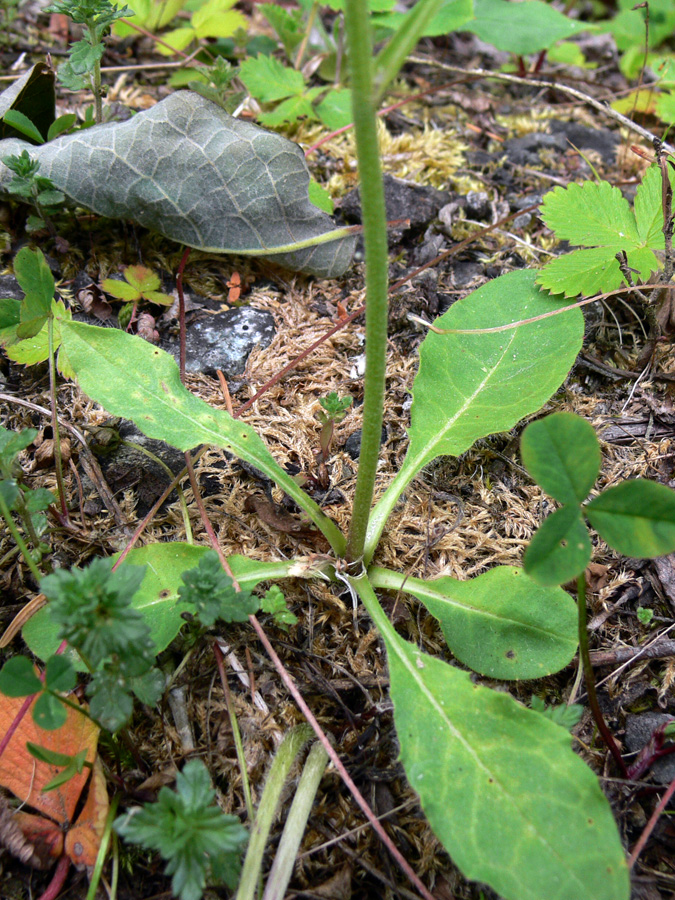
[{"xmin": 523, "ymin": 506, "xmax": 593, "ymax": 587}]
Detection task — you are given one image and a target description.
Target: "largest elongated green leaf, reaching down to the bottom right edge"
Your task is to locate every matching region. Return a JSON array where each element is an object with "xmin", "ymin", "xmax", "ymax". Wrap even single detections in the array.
[{"xmin": 352, "ymin": 578, "xmax": 630, "ymax": 900}]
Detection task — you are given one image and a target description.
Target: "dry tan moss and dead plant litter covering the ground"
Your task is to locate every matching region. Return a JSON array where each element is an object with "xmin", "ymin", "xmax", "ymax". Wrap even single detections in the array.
[{"xmin": 0, "ymin": 28, "xmax": 675, "ymax": 900}]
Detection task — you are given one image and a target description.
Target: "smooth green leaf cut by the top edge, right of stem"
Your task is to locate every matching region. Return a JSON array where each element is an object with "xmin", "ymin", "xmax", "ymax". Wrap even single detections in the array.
[{"xmin": 465, "ymin": 0, "xmax": 593, "ymax": 56}]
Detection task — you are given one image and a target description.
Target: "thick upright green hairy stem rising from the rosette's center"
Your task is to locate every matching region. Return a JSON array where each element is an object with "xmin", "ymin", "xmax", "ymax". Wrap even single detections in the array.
[{"xmin": 345, "ymin": 0, "xmax": 388, "ymax": 562}]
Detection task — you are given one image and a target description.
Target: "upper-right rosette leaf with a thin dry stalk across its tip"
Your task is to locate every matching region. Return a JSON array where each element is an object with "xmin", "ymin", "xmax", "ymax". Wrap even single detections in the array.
[{"xmin": 366, "ymin": 270, "xmax": 583, "ymax": 559}]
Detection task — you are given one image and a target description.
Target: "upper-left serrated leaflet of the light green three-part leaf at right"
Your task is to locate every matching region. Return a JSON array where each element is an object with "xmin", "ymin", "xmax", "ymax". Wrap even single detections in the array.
[{"xmin": 540, "ymin": 181, "xmax": 641, "ymax": 253}]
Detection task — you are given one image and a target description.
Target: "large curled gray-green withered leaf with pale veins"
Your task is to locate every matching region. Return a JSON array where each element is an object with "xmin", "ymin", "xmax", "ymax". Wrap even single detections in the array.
[{"xmin": 0, "ymin": 91, "xmax": 355, "ymax": 277}]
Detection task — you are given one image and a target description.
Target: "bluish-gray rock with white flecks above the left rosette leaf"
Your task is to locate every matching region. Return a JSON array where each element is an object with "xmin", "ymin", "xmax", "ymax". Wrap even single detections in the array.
[{"xmin": 163, "ymin": 306, "xmax": 275, "ymax": 378}]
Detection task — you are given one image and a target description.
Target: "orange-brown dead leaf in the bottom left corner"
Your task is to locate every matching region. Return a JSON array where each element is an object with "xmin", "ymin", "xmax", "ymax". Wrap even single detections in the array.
[{"xmin": 0, "ymin": 694, "xmax": 108, "ymax": 869}]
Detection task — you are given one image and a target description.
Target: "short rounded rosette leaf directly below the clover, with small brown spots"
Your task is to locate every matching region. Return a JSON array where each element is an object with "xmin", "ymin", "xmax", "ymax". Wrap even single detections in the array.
[{"xmin": 368, "ymin": 566, "xmax": 577, "ymax": 679}]
